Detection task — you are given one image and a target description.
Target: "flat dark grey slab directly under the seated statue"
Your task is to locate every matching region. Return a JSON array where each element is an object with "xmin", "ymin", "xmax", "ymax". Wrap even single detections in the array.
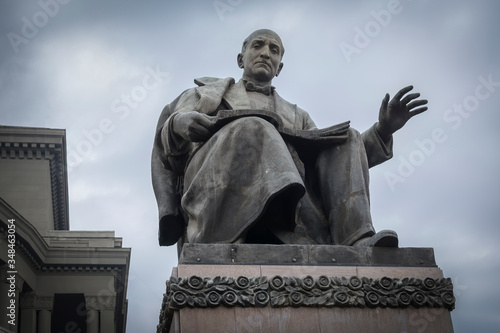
[{"xmin": 179, "ymin": 244, "xmax": 436, "ymax": 267}]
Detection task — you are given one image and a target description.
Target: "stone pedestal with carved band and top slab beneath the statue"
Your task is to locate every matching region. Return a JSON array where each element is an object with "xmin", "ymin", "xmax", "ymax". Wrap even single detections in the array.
[{"xmin": 158, "ymin": 244, "xmax": 455, "ymax": 333}]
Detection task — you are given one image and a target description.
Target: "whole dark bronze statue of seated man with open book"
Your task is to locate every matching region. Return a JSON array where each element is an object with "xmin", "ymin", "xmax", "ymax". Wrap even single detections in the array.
[{"xmin": 152, "ymin": 29, "xmax": 427, "ymax": 247}]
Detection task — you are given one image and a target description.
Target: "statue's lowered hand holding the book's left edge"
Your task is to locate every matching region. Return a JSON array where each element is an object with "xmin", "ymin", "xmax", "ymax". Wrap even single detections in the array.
[{"xmin": 173, "ymin": 111, "xmax": 214, "ymax": 142}]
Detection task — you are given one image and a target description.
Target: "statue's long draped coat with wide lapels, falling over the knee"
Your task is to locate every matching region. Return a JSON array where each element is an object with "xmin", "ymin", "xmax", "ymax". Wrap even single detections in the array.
[{"xmin": 152, "ymin": 78, "xmax": 392, "ymax": 245}]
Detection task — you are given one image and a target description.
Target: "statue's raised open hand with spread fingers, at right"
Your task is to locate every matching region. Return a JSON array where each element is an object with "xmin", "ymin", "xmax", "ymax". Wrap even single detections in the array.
[{"xmin": 377, "ymin": 86, "xmax": 427, "ymax": 141}]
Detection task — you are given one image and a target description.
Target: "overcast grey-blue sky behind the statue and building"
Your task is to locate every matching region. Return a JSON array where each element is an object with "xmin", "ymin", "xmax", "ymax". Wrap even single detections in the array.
[{"xmin": 0, "ymin": 0, "xmax": 500, "ymax": 332}]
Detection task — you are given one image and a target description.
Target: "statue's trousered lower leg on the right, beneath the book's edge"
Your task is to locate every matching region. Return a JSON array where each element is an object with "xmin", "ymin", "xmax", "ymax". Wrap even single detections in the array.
[{"xmin": 316, "ymin": 129, "xmax": 375, "ymax": 245}]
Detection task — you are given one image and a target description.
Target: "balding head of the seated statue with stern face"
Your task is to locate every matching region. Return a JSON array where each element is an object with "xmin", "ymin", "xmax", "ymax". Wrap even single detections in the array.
[{"xmin": 237, "ymin": 29, "xmax": 285, "ymax": 85}]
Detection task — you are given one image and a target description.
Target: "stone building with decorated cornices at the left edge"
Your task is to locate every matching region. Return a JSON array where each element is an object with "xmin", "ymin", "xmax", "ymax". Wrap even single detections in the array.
[{"xmin": 0, "ymin": 126, "xmax": 130, "ymax": 333}]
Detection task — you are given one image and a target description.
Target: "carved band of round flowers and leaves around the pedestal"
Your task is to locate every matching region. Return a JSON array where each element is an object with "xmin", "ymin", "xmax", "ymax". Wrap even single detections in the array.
[{"xmin": 164, "ymin": 275, "xmax": 455, "ymax": 310}]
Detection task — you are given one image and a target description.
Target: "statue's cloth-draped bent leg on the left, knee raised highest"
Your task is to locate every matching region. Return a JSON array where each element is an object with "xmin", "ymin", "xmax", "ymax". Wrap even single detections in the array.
[{"xmin": 182, "ymin": 117, "xmax": 305, "ymax": 243}]
